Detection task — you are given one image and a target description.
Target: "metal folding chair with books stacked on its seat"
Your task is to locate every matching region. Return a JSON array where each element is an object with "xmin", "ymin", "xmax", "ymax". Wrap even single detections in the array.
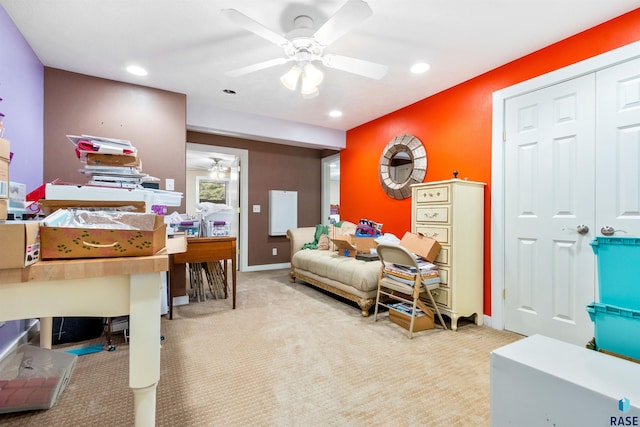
[{"xmin": 373, "ymin": 243, "xmax": 447, "ymax": 338}]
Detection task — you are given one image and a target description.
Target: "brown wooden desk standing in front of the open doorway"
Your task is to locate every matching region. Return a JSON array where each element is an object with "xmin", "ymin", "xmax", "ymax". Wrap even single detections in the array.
[{"xmin": 169, "ymin": 236, "xmax": 236, "ymax": 319}]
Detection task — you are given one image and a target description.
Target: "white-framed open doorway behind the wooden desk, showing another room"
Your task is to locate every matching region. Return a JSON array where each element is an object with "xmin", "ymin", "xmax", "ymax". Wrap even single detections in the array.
[{"xmin": 185, "ymin": 142, "xmax": 249, "ymax": 271}]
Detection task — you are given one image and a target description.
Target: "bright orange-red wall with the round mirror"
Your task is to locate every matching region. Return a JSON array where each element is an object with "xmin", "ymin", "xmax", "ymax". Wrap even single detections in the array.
[{"xmin": 340, "ymin": 8, "xmax": 640, "ymax": 315}]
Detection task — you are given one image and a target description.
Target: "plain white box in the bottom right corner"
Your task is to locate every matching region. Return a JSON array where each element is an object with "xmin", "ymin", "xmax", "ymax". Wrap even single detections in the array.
[{"xmin": 490, "ymin": 335, "xmax": 640, "ymax": 427}]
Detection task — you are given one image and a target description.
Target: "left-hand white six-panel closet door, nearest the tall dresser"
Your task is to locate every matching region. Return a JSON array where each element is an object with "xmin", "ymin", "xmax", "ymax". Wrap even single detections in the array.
[{"xmin": 504, "ymin": 75, "xmax": 595, "ymax": 345}]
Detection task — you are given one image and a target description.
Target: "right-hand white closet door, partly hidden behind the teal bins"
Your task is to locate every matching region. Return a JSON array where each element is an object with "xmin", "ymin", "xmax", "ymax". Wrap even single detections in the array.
[{"xmin": 594, "ymin": 59, "xmax": 640, "ymax": 241}]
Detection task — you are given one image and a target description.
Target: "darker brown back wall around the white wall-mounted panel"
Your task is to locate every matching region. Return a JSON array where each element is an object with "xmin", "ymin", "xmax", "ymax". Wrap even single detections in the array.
[{"xmin": 187, "ymin": 131, "xmax": 324, "ymax": 266}]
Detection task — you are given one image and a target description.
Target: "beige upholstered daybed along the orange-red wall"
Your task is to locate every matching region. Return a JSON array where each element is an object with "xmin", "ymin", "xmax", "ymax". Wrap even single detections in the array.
[{"xmin": 287, "ymin": 223, "xmax": 381, "ymax": 317}]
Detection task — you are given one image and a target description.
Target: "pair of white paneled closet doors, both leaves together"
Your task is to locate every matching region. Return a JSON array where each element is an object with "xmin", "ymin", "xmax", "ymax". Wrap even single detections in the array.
[{"xmin": 505, "ymin": 59, "xmax": 640, "ymax": 345}]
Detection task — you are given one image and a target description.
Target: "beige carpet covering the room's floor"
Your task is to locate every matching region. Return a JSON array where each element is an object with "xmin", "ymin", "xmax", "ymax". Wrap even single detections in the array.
[{"xmin": 0, "ymin": 270, "xmax": 521, "ymax": 427}]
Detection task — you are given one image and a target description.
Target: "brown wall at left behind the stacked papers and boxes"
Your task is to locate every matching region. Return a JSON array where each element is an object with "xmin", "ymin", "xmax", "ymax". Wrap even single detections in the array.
[{"xmin": 43, "ymin": 67, "xmax": 187, "ymax": 212}]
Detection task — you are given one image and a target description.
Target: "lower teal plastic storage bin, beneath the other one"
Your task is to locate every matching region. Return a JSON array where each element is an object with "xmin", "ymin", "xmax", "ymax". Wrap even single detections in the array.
[{"xmin": 587, "ymin": 302, "xmax": 640, "ymax": 361}]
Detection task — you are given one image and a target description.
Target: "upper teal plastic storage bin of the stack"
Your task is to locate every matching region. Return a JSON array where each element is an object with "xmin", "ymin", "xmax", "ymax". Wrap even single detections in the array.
[{"xmin": 590, "ymin": 236, "xmax": 640, "ymax": 310}]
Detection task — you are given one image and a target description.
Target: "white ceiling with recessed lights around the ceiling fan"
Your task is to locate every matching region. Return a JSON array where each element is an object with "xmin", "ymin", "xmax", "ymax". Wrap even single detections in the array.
[{"xmin": 0, "ymin": 0, "xmax": 639, "ymax": 134}]
